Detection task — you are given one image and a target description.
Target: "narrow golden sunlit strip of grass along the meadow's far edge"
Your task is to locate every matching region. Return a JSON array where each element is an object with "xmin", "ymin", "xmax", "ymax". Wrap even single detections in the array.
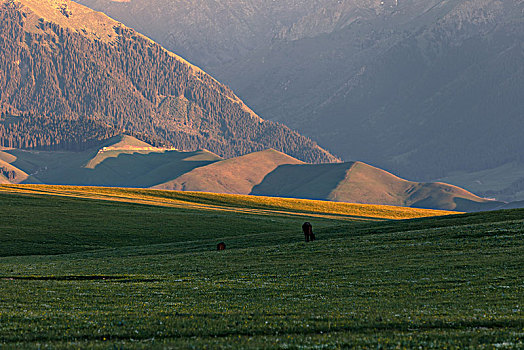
[{"xmin": 0, "ymin": 185, "xmax": 457, "ymax": 220}]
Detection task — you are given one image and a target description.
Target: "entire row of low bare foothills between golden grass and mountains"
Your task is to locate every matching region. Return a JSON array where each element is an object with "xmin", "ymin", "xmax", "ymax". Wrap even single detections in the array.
[{"xmin": 0, "ymin": 136, "xmax": 506, "ymax": 211}]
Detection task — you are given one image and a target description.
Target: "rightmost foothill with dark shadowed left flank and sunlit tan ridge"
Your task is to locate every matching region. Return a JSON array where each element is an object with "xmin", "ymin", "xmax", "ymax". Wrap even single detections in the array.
[{"xmin": 252, "ymin": 162, "xmax": 500, "ymax": 211}]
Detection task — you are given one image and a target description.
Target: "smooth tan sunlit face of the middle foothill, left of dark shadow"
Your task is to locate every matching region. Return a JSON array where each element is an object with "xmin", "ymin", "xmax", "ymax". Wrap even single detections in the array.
[{"xmin": 155, "ymin": 149, "xmax": 303, "ymax": 194}]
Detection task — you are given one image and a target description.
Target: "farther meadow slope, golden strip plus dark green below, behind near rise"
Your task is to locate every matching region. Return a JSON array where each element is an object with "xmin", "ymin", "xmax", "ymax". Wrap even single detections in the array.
[{"xmin": 0, "ymin": 185, "xmax": 450, "ymax": 256}]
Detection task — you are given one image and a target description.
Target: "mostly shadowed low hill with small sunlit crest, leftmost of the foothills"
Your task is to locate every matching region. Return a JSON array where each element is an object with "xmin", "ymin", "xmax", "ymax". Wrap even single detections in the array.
[{"xmin": 0, "ymin": 136, "xmax": 222, "ymax": 187}]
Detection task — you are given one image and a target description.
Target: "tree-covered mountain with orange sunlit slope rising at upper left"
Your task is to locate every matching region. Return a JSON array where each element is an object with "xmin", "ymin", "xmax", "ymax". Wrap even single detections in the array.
[{"xmin": 0, "ymin": 0, "xmax": 337, "ymax": 162}]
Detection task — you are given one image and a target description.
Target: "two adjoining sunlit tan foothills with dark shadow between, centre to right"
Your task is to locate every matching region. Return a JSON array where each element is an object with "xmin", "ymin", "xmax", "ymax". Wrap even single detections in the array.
[{"xmin": 161, "ymin": 150, "xmax": 504, "ymax": 211}]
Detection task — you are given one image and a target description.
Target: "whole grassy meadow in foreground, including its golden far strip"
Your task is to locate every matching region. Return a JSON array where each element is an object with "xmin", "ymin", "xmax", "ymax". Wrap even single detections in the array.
[{"xmin": 0, "ymin": 186, "xmax": 524, "ymax": 349}]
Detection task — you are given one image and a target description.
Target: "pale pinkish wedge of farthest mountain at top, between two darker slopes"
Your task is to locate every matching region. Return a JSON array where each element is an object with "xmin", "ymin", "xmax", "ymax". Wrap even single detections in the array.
[{"xmin": 76, "ymin": 0, "xmax": 328, "ymax": 72}]
